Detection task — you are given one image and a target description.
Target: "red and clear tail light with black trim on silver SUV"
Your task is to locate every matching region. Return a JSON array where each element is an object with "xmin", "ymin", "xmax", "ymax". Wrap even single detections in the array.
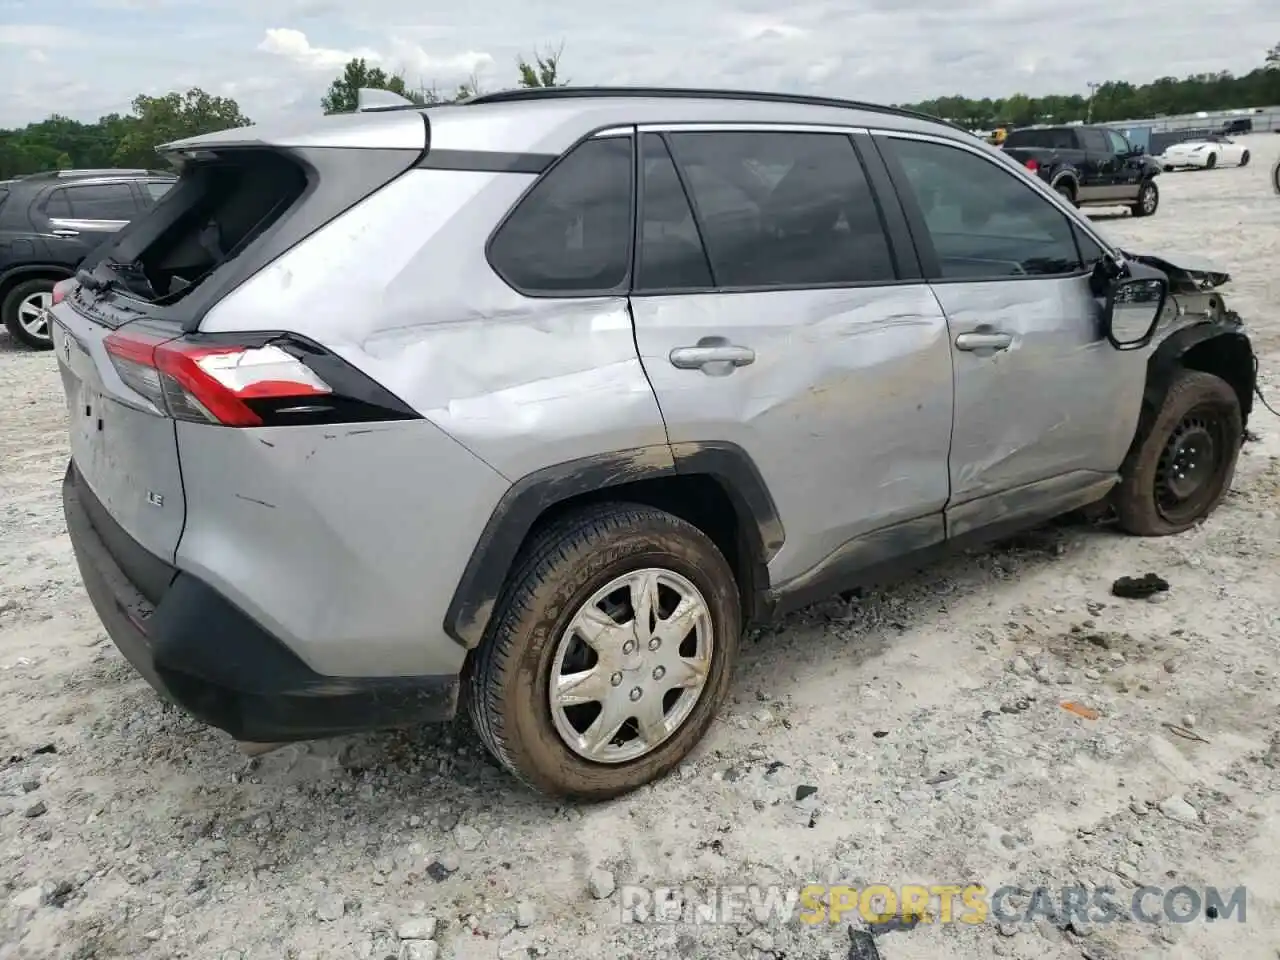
[{"xmin": 104, "ymin": 330, "xmax": 419, "ymax": 426}]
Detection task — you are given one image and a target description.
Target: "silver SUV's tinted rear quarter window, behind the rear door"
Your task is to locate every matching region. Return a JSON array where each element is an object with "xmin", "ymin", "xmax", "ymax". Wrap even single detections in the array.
[{"xmin": 489, "ymin": 137, "xmax": 631, "ymax": 294}]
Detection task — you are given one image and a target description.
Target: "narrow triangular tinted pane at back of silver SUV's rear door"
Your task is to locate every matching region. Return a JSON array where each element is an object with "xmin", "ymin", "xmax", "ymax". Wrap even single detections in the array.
[{"xmin": 636, "ymin": 133, "xmax": 712, "ymax": 291}]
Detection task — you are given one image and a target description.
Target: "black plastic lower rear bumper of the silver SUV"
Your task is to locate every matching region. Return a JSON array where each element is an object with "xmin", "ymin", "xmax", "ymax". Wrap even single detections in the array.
[{"xmin": 63, "ymin": 463, "xmax": 458, "ymax": 742}]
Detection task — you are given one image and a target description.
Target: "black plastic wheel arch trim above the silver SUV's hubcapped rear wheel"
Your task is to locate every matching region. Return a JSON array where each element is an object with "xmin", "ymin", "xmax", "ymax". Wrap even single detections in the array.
[{"xmin": 444, "ymin": 442, "xmax": 783, "ymax": 649}]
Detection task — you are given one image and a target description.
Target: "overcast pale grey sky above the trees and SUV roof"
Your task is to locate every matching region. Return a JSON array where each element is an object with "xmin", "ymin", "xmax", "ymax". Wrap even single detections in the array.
[{"xmin": 0, "ymin": 0, "xmax": 1280, "ymax": 127}]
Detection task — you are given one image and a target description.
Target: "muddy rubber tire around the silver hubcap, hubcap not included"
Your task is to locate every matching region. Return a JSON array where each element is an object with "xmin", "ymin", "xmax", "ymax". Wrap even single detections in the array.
[{"xmin": 466, "ymin": 503, "xmax": 742, "ymax": 800}]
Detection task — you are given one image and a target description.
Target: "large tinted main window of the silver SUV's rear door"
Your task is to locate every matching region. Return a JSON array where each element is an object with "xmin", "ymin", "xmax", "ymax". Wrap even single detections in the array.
[{"xmin": 669, "ymin": 132, "xmax": 895, "ymax": 287}]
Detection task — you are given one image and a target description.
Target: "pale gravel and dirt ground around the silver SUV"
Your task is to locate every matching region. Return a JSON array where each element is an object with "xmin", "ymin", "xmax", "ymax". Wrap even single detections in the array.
[{"xmin": 0, "ymin": 134, "xmax": 1280, "ymax": 960}]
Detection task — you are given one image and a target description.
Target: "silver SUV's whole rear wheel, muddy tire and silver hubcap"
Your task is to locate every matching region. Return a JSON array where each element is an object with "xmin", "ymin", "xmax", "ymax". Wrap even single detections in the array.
[{"xmin": 467, "ymin": 503, "xmax": 742, "ymax": 800}]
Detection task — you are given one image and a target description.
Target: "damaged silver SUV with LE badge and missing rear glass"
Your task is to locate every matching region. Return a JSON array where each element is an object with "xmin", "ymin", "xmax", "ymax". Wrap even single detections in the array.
[{"xmin": 51, "ymin": 88, "xmax": 1254, "ymax": 799}]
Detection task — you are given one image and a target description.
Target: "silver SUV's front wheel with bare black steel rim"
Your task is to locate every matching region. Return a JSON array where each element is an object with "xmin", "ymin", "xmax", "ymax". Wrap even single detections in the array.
[{"xmin": 1115, "ymin": 370, "xmax": 1244, "ymax": 536}]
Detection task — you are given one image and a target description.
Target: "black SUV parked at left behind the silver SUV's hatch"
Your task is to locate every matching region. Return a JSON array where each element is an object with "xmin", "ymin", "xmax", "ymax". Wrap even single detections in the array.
[{"xmin": 0, "ymin": 170, "xmax": 177, "ymax": 349}]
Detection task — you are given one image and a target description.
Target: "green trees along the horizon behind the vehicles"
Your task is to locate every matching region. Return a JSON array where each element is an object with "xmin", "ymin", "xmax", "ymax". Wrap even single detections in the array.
[{"xmin": 0, "ymin": 44, "xmax": 1280, "ymax": 179}]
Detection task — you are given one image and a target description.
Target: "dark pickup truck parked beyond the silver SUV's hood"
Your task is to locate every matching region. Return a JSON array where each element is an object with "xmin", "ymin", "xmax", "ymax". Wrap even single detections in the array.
[{"xmin": 1004, "ymin": 127, "xmax": 1160, "ymax": 216}]
